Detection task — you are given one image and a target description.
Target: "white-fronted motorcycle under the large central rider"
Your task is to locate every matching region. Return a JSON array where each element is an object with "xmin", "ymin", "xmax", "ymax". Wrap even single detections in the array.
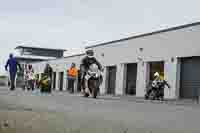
[{"xmin": 84, "ymin": 64, "xmax": 103, "ymax": 98}]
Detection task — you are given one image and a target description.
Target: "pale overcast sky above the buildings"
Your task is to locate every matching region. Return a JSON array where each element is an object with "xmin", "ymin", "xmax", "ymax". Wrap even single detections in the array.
[{"xmin": 0, "ymin": 0, "xmax": 200, "ymax": 72}]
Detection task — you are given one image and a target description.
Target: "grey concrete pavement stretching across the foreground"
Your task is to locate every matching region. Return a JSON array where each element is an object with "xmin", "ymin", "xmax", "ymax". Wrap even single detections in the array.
[{"xmin": 0, "ymin": 87, "xmax": 200, "ymax": 133}]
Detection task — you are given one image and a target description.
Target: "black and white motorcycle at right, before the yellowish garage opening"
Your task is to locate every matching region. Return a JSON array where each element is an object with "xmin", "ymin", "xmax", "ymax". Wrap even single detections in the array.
[{"xmin": 145, "ymin": 80, "xmax": 170, "ymax": 101}]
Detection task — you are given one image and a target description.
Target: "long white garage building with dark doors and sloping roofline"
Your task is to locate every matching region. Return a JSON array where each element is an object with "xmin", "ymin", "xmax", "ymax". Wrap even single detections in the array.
[{"xmin": 32, "ymin": 22, "xmax": 200, "ymax": 99}]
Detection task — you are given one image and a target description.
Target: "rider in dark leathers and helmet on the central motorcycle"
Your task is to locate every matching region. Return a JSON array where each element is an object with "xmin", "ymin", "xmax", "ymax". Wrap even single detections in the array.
[{"xmin": 80, "ymin": 50, "xmax": 102, "ymax": 95}]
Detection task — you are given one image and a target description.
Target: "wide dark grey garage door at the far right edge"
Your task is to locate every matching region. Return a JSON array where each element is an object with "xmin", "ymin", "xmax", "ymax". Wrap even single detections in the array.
[{"xmin": 180, "ymin": 57, "xmax": 200, "ymax": 98}]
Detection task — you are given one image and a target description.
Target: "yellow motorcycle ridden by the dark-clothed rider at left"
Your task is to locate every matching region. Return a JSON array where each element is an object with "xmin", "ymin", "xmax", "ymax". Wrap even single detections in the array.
[{"xmin": 39, "ymin": 75, "xmax": 51, "ymax": 93}]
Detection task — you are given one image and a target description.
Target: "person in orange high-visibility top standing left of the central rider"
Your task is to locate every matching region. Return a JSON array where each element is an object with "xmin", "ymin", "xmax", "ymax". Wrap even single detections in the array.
[{"xmin": 67, "ymin": 63, "xmax": 78, "ymax": 93}]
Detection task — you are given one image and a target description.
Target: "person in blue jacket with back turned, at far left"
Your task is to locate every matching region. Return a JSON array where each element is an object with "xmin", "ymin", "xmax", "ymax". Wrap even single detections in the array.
[{"xmin": 5, "ymin": 54, "xmax": 21, "ymax": 90}]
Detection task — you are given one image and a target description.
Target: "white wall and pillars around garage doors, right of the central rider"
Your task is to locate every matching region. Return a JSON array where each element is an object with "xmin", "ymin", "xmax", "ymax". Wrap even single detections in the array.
[{"xmin": 89, "ymin": 25, "xmax": 200, "ymax": 99}]
